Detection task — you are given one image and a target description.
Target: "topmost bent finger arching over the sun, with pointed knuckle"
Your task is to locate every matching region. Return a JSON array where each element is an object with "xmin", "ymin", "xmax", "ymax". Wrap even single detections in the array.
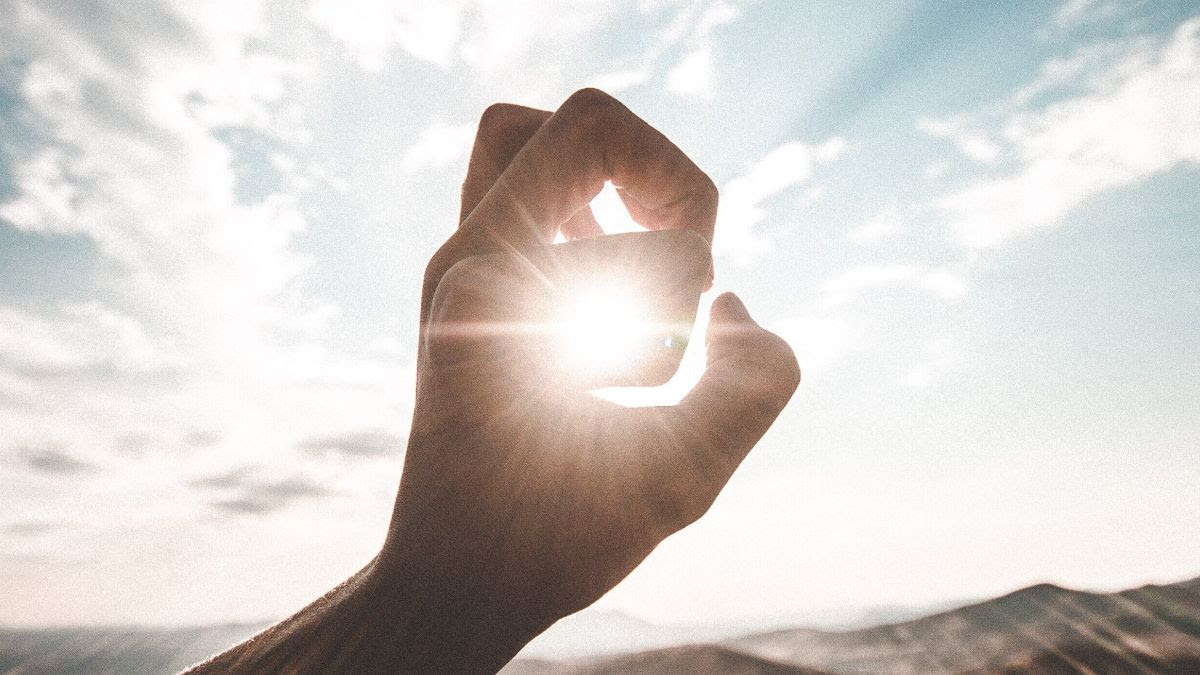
[{"xmin": 462, "ymin": 89, "xmax": 716, "ymax": 250}]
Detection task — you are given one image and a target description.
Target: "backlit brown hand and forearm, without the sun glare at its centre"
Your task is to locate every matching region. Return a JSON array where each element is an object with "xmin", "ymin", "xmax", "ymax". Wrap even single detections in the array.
[{"xmin": 191, "ymin": 89, "xmax": 800, "ymax": 673}]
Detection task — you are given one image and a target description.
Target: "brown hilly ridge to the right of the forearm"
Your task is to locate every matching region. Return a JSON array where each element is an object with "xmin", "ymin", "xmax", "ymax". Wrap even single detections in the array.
[{"xmin": 504, "ymin": 578, "xmax": 1200, "ymax": 675}]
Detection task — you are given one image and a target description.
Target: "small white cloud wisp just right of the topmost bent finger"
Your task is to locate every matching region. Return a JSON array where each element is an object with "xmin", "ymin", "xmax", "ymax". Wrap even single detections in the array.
[{"xmin": 713, "ymin": 138, "xmax": 846, "ymax": 262}]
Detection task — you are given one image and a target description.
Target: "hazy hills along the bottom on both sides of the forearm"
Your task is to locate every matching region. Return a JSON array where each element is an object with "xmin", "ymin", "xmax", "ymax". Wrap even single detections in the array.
[{"xmin": 0, "ymin": 571, "xmax": 1200, "ymax": 675}]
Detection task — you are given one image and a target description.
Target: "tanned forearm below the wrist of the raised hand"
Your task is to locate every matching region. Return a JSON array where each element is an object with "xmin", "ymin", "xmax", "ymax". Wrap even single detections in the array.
[{"xmin": 187, "ymin": 561, "xmax": 542, "ymax": 674}]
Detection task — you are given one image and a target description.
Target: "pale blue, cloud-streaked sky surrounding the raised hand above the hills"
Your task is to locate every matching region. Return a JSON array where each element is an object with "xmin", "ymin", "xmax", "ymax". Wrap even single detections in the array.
[{"xmin": 0, "ymin": 0, "xmax": 1200, "ymax": 626}]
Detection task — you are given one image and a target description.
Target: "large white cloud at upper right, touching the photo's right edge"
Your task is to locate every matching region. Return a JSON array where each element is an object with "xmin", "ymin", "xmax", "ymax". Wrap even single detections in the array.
[{"xmin": 936, "ymin": 19, "xmax": 1200, "ymax": 247}]
